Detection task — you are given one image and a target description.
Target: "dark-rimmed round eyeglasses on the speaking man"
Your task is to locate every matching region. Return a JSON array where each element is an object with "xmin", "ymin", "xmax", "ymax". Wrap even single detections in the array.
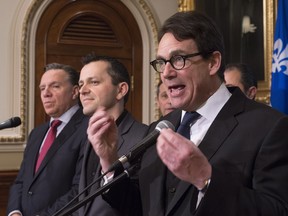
[{"xmin": 150, "ymin": 52, "xmax": 203, "ymax": 73}]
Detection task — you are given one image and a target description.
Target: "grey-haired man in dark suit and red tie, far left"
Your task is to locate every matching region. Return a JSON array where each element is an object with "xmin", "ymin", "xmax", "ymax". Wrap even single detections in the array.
[{"xmin": 7, "ymin": 63, "xmax": 88, "ymax": 216}]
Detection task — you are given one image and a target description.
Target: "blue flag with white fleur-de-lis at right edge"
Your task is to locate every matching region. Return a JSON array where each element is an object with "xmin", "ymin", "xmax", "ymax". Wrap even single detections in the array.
[{"xmin": 271, "ymin": 0, "xmax": 288, "ymax": 114}]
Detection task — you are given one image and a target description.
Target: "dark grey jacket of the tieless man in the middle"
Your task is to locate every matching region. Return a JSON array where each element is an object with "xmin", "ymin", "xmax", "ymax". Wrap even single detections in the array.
[{"xmin": 79, "ymin": 112, "xmax": 148, "ymax": 216}]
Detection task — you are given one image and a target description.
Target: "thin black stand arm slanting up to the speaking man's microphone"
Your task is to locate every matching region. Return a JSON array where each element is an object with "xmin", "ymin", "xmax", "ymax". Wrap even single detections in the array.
[{"xmin": 53, "ymin": 163, "xmax": 139, "ymax": 216}]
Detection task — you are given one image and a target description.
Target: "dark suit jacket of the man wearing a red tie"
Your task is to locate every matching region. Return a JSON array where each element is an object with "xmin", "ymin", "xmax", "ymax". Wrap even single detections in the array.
[{"xmin": 7, "ymin": 108, "xmax": 88, "ymax": 216}]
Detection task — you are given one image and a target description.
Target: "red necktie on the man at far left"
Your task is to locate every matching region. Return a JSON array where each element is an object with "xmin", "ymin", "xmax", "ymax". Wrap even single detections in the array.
[{"xmin": 35, "ymin": 120, "xmax": 62, "ymax": 172}]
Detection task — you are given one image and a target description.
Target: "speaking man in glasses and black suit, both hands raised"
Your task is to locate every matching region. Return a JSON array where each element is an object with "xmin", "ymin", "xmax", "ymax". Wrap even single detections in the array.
[{"xmin": 88, "ymin": 11, "xmax": 288, "ymax": 216}]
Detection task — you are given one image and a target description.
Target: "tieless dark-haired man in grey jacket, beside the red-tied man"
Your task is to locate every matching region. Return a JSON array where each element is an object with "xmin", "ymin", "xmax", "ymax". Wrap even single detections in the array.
[{"xmin": 73, "ymin": 54, "xmax": 148, "ymax": 216}]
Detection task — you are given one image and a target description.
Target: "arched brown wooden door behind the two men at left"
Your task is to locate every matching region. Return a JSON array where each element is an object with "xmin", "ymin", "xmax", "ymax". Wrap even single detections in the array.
[{"xmin": 35, "ymin": 0, "xmax": 143, "ymax": 126}]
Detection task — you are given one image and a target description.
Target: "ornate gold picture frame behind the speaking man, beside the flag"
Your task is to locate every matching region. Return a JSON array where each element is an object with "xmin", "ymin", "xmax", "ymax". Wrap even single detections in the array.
[{"xmin": 178, "ymin": 0, "xmax": 277, "ymax": 104}]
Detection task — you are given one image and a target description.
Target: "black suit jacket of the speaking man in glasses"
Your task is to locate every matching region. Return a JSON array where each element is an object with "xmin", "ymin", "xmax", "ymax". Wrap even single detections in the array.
[{"xmin": 106, "ymin": 88, "xmax": 288, "ymax": 216}]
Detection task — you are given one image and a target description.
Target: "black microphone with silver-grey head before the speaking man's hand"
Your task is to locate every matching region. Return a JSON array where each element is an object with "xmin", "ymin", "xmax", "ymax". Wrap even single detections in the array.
[{"xmin": 105, "ymin": 120, "xmax": 175, "ymax": 173}]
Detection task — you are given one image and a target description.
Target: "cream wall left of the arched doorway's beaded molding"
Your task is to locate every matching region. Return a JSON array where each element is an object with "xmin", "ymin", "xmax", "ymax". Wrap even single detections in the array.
[{"xmin": 0, "ymin": 0, "xmax": 31, "ymax": 170}]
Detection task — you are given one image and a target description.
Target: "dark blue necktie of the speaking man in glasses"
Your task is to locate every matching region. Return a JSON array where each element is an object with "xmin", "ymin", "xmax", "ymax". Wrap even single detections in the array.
[{"xmin": 177, "ymin": 112, "xmax": 200, "ymax": 140}]
